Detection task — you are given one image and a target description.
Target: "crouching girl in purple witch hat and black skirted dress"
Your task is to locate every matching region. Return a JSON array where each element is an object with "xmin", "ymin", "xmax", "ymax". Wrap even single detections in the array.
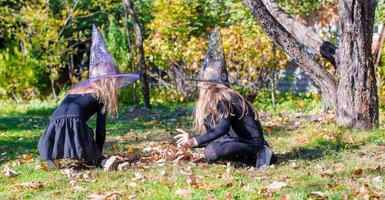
[{"xmin": 38, "ymin": 26, "xmax": 140, "ymax": 169}]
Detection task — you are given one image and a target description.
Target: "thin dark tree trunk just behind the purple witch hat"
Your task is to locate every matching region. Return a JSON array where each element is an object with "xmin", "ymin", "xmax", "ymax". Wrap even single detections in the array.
[{"xmin": 124, "ymin": 0, "xmax": 151, "ymax": 108}]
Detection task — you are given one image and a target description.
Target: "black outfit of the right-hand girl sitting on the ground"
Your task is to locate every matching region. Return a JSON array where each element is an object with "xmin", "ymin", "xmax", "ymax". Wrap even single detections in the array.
[{"xmin": 195, "ymin": 102, "xmax": 268, "ymax": 165}]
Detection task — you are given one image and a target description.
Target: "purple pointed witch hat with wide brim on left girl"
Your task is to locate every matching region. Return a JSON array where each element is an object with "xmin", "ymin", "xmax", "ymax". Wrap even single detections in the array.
[{"xmin": 74, "ymin": 25, "xmax": 140, "ymax": 88}]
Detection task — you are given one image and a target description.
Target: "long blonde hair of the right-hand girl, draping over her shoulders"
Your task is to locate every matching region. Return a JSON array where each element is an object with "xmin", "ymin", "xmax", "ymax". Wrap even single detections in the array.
[{"xmin": 193, "ymin": 82, "xmax": 258, "ymax": 133}]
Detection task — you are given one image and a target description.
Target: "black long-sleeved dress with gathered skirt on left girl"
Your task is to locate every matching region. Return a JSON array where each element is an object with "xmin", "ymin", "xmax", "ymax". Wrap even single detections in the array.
[{"xmin": 38, "ymin": 93, "xmax": 106, "ymax": 162}]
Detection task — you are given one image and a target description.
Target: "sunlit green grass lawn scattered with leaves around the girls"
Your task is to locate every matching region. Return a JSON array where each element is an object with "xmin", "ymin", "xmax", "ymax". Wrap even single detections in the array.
[{"xmin": 0, "ymin": 99, "xmax": 385, "ymax": 199}]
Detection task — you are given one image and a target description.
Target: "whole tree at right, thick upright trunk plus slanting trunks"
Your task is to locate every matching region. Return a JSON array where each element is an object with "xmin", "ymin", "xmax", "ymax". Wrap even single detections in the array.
[{"xmin": 243, "ymin": 0, "xmax": 379, "ymax": 129}]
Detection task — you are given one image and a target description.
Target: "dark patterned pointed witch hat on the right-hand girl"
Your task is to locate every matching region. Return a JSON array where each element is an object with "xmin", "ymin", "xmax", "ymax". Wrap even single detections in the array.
[{"xmin": 189, "ymin": 27, "xmax": 230, "ymax": 85}]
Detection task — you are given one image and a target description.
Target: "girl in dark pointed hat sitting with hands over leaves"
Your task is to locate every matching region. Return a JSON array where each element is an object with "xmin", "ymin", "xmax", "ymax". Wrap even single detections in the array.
[{"xmin": 175, "ymin": 29, "xmax": 277, "ymax": 168}]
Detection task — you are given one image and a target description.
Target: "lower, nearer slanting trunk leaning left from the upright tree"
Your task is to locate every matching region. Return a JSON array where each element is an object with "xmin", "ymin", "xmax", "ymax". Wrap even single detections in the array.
[{"xmin": 243, "ymin": 0, "xmax": 337, "ymax": 107}]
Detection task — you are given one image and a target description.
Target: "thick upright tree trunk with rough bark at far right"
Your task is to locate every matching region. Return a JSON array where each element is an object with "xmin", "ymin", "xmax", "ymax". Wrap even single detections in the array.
[{"xmin": 337, "ymin": 0, "xmax": 379, "ymax": 129}]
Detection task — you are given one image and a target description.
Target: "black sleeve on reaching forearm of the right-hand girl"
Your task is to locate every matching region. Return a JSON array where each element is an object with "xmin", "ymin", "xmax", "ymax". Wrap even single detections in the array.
[{"xmin": 195, "ymin": 118, "xmax": 231, "ymax": 146}]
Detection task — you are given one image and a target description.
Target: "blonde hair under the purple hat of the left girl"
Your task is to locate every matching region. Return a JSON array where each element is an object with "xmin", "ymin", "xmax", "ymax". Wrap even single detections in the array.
[{"xmin": 68, "ymin": 78, "xmax": 121, "ymax": 116}]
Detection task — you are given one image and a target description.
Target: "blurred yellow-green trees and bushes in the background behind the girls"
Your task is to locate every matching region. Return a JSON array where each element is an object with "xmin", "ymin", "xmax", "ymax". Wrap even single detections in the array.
[{"xmin": 0, "ymin": 0, "xmax": 385, "ymax": 115}]
